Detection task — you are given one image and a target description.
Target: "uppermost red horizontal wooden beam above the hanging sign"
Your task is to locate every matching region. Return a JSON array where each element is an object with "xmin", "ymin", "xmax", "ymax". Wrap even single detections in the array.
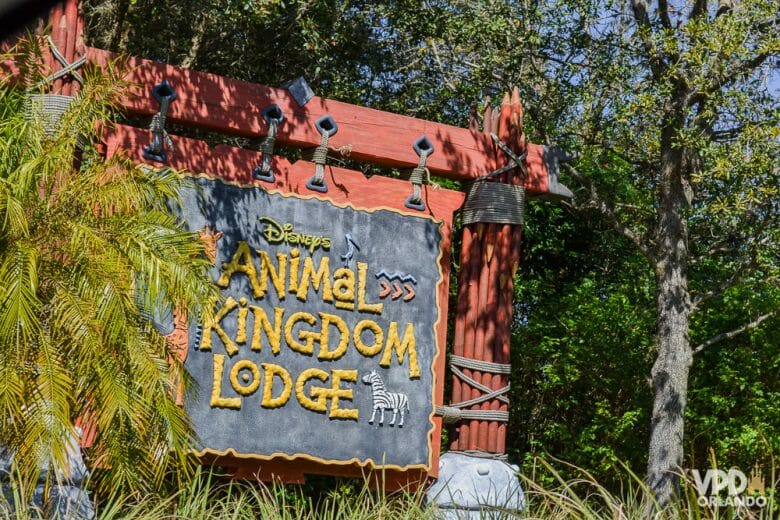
[{"xmin": 87, "ymin": 47, "xmax": 548, "ymax": 195}]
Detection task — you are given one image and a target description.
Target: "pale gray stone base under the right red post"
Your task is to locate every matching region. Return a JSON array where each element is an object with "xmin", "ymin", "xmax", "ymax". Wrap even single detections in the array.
[{"xmin": 426, "ymin": 452, "xmax": 525, "ymax": 520}]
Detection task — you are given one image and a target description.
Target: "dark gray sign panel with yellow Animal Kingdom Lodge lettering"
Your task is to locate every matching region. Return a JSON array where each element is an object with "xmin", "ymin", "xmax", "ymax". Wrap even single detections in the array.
[{"xmin": 178, "ymin": 178, "xmax": 442, "ymax": 469}]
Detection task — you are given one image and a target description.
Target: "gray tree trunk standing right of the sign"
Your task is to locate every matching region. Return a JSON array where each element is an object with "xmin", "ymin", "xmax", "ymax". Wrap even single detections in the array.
[{"xmin": 647, "ymin": 115, "xmax": 693, "ymax": 507}]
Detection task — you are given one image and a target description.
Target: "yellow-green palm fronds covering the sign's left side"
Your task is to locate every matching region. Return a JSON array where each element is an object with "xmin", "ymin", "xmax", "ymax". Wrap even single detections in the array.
[{"xmin": 0, "ymin": 40, "xmax": 215, "ymax": 491}]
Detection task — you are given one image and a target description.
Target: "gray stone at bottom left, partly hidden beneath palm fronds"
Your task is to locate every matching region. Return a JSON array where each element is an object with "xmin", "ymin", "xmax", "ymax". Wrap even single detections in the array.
[{"xmin": 0, "ymin": 428, "xmax": 95, "ymax": 520}]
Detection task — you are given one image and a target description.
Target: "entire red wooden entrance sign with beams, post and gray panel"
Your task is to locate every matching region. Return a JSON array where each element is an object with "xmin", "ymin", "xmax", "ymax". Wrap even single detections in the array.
[{"xmin": 12, "ymin": 0, "xmax": 570, "ymax": 488}]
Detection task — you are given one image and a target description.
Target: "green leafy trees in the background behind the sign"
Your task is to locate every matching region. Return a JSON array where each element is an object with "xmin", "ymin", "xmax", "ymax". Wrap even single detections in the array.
[{"xmin": 77, "ymin": 0, "xmax": 780, "ymax": 500}]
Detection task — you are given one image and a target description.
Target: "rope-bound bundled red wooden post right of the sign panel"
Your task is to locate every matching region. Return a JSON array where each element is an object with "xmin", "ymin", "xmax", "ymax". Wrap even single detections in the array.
[{"xmin": 450, "ymin": 89, "xmax": 525, "ymax": 453}]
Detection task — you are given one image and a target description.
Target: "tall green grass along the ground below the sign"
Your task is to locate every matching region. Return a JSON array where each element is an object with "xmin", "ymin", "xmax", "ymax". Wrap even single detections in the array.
[{"xmin": 0, "ymin": 459, "xmax": 780, "ymax": 520}]
